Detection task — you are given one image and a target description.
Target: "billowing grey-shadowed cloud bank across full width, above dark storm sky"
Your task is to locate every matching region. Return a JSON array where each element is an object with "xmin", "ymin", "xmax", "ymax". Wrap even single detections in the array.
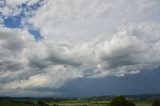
[{"xmin": 0, "ymin": 23, "xmax": 160, "ymax": 93}]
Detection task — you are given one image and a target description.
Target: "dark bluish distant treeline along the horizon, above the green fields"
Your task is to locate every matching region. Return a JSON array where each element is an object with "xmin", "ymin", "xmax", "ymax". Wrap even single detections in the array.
[{"xmin": 0, "ymin": 94, "xmax": 160, "ymax": 102}]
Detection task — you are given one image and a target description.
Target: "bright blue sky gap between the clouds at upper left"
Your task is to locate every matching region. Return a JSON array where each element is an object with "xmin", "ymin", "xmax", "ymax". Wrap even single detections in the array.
[{"xmin": 0, "ymin": 0, "xmax": 43, "ymax": 41}]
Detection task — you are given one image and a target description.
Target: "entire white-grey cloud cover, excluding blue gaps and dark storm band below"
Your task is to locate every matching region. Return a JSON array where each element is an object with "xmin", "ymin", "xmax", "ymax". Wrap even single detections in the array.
[{"xmin": 0, "ymin": 0, "xmax": 160, "ymax": 95}]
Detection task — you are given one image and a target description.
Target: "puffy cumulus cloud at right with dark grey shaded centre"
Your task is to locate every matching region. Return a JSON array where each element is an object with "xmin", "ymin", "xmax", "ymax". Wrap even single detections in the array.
[{"xmin": 94, "ymin": 23, "xmax": 160, "ymax": 76}]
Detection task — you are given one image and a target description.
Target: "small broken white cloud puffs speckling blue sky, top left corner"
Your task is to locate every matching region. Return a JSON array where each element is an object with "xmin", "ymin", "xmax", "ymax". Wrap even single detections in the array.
[{"xmin": 0, "ymin": 0, "xmax": 43, "ymax": 17}]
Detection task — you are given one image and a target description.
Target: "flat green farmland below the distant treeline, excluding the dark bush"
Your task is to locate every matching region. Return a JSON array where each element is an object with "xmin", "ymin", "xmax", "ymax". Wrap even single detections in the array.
[{"xmin": 0, "ymin": 98, "xmax": 152, "ymax": 106}]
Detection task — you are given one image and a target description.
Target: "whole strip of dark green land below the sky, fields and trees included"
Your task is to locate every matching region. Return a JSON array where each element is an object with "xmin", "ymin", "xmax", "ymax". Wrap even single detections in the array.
[{"xmin": 0, "ymin": 95, "xmax": 160, "ymax": 106}]
